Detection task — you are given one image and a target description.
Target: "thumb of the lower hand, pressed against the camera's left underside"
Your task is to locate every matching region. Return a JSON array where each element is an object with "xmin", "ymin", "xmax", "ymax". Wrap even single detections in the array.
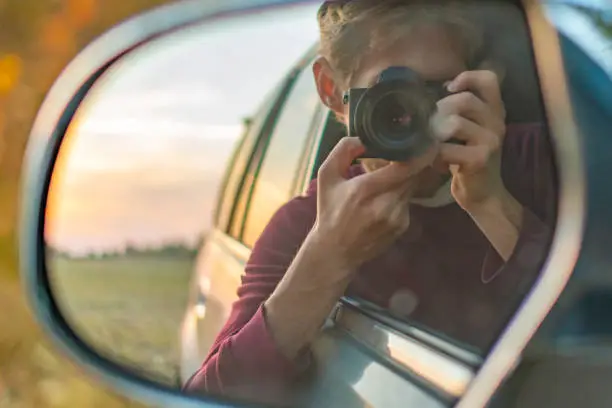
[{"xmin": 318, "ymin": 137, "xmax": 365, "ymax": 183}]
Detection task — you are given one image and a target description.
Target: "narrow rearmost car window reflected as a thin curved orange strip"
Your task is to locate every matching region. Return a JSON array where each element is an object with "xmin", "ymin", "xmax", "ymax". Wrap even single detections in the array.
[{"xmin": 216, "ymin": 86, "xmax": 283, "ymax": 233}]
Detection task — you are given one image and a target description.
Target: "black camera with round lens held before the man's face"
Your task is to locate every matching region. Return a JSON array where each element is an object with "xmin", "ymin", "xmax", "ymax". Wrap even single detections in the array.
[{"xmin": 343, "ymin": 67, "xmax": 451, "ymax": 161}]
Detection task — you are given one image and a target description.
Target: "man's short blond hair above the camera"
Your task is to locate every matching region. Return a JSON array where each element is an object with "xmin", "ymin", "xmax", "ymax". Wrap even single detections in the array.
[{"xmin": 317, "ymin": 0, "xmax": 483, "ymax": 89}]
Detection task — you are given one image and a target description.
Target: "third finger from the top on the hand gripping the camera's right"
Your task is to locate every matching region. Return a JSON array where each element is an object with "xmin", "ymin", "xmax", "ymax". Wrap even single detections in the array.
[{"xmin": 432, "ymin": 115, "xmax": 501, "ymax": 150}]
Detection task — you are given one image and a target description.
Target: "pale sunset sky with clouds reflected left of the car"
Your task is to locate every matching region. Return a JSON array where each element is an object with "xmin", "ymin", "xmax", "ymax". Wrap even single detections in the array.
[{"xmin": 47, "ymin": 5, "xmax": 317, "ymax": 251}]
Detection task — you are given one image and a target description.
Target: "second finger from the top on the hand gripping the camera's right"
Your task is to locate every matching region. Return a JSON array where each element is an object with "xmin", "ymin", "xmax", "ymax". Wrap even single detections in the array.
[{"xmin": 437, "ymin": 91, "xmax": 494, "ymax": 128}]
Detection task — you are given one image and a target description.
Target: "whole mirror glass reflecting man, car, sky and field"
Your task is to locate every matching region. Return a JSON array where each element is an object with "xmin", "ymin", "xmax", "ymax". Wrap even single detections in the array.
[{"xmin": 45, "ymin": 0, "xmax": 557, "ymax": 406}]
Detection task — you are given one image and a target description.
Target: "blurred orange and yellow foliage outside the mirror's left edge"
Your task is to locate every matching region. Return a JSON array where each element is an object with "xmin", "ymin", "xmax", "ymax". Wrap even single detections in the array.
[{"xmin": 0, "ymin": 0, "xmax": 170, "ymax": 408}]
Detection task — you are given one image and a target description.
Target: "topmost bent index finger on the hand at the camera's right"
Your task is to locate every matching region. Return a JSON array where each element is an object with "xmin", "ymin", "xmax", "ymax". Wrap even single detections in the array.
[{"xmin": 448, "ymin": 70, "xmax": 505, "ymax": 120}]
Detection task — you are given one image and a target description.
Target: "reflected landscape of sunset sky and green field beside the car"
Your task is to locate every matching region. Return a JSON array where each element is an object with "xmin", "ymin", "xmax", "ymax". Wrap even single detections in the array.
[{"xmin": 45, "ymin": 6, "xmax": 316, "ymax": 386}]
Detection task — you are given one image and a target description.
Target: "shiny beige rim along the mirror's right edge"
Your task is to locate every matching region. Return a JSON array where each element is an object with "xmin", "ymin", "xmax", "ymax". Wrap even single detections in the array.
[{"xmin": 457, "ymin": 0, "xmax": 586, "ymax": 408}]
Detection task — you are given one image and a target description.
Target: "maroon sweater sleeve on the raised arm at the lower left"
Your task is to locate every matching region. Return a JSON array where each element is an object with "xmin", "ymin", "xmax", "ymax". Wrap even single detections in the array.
[{"xmin": 185, "ymin": 182, "xmax": 316, "ymax": 402}]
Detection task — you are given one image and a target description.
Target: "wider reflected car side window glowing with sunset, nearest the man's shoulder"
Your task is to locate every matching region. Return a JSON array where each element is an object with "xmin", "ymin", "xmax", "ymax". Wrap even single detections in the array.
[{"xmin": 242, "ymin": 67, "xmax": 320, "ymax": 247}]
